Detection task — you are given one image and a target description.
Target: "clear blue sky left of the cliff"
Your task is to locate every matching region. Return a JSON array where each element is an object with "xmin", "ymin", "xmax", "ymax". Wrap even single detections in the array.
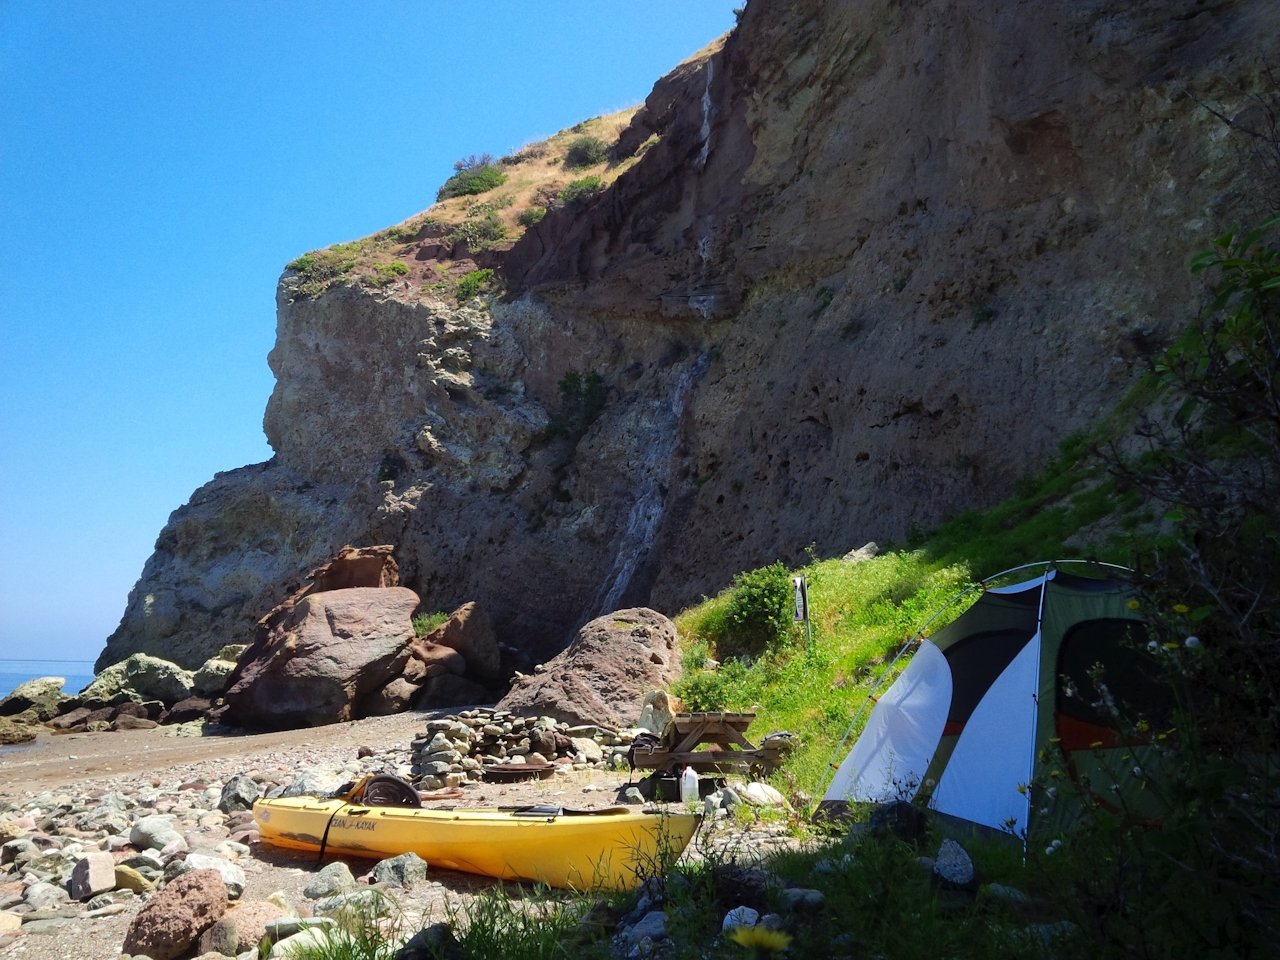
[{"xmin": 0, "ymin": 0, "xmax": 741, "ymax": 658}]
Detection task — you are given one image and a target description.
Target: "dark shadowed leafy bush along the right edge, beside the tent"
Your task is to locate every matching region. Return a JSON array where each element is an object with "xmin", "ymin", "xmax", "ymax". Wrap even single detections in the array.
[{"xmin": 1061, "ymin": 216, "xmax": 1280, "ymax": 956}]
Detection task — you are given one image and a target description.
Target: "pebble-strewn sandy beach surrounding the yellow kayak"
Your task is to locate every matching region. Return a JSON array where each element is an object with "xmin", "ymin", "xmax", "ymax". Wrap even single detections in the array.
[{"xmin": 0, "ymin": 712, "xmax": 791, "ymax": 960}]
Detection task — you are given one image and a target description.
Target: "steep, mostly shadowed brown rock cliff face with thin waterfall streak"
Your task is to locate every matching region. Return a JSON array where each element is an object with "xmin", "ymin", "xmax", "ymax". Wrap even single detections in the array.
[{"xmin": 100, "ymin": 0, "xmax": 1280, "ymax": 666}]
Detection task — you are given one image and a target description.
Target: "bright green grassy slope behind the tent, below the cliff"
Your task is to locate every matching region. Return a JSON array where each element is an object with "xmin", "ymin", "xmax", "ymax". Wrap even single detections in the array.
[{"xmin": 676, "ymin": 417, "xmax": 1153, "ymax": 792}]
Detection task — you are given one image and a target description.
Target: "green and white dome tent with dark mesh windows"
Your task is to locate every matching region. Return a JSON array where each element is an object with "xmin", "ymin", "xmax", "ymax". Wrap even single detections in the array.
[{"xmin": 819, "ymin": 563, "xmax": 1167, "ymax": 835}]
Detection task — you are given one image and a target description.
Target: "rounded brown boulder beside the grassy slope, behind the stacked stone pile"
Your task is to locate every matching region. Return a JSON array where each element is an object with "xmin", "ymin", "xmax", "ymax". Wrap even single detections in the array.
[{"xmin": 498, "ymin": 607, "xmax": 680, "ymax": 726}]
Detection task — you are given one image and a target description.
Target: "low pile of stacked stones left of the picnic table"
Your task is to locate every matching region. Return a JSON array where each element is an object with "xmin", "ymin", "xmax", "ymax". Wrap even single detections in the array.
[{"xmin": 411, "ymin": 708, "xmax": 644, "ymax": 790}]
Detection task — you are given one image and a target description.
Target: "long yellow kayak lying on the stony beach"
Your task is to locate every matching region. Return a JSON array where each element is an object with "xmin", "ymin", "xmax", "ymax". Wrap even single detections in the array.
[{"xmin": 253, "ymin": 796, "xmax": 701, "ymax": 890}]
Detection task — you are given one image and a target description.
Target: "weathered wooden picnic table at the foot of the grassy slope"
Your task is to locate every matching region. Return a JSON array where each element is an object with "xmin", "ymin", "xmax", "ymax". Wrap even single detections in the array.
[{"xmin": 634, "ymin": 713, "xmax": 794, "ymax": 776}]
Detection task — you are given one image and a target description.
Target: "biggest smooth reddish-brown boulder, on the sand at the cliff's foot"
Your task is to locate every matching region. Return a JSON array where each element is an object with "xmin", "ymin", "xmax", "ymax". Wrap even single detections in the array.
[{"xmin": 225, "ymin": 586, "xmax": 419, "ymax": 730}]
